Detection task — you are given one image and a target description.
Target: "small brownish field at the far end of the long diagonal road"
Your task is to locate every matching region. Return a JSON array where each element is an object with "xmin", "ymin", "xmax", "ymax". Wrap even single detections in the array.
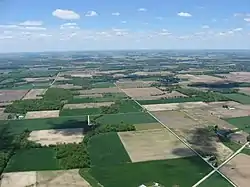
[{"xmin": 116, "ymin": 81, "xmax": 155, "ymax": 89}]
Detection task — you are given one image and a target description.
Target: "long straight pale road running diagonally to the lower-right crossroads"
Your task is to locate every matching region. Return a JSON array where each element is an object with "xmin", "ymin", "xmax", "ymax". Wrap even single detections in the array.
[{"xmin": 114, "ymin": 83, "xmax": 237, "ymax": 187}]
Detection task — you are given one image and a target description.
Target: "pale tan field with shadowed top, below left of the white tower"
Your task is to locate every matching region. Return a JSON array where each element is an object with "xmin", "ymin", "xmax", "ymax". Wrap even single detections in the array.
[{"xmin": 28, "ymin": 128, "xmax": 83, "ymax": 146}]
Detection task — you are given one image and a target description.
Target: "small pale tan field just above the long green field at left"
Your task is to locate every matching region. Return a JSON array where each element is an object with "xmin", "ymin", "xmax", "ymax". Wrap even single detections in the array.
[{"xmin": 25, "ymin": 110, "xmax": 60, "ymax": 119}]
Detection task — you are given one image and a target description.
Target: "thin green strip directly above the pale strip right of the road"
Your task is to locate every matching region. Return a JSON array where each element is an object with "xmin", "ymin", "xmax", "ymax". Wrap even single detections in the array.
[{"xmin": 138, "ymin": 97, "xmax": 203, "ymax": 105}]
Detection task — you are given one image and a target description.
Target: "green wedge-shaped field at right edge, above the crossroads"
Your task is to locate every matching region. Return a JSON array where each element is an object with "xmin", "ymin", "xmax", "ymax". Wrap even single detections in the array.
[{"xmin": 224, "ymin": 116, "xmax": 250, "ymax": 133}]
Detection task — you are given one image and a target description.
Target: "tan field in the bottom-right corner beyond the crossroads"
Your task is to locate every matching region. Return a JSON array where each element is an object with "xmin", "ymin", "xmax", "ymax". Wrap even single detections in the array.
[{"xmin": 220, "ymin": 153, "xmax": 250, "ymax": 187}]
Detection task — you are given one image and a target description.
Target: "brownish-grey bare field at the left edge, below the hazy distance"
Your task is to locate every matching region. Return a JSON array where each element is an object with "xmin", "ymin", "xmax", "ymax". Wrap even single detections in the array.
[{"xmin": 0, "ymin": 90, "xmax": 29, "ymax": 102}]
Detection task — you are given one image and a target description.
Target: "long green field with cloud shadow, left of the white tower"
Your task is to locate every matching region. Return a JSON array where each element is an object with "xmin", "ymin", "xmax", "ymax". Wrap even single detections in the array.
[{"xmin": 0, "ymin": 116, "xmax": 86, "ymax": 133}]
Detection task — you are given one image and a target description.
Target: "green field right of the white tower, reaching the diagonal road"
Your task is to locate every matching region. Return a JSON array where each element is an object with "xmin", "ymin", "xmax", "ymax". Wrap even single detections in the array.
[{"xmin": 91, "ymin": 112, "xmax": 156, "ymax": 125}]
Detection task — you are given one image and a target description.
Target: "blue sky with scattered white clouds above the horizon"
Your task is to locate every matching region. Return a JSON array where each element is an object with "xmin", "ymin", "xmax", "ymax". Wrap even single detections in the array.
[{"xmin": 0, "ymin": 0, "xmax": 250, "ymax": 52}]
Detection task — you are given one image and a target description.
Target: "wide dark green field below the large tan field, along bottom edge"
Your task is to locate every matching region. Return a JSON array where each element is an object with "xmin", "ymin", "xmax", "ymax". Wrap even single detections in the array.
[{"xmin": 86, "ymin": 157, "xmax": 211, "ymax": 187}]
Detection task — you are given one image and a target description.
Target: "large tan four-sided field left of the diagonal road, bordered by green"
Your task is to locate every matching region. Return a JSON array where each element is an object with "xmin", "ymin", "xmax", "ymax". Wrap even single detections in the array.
[{"xmin": 118, "ymin": 129, "xmax": 193, "ymax": 162}]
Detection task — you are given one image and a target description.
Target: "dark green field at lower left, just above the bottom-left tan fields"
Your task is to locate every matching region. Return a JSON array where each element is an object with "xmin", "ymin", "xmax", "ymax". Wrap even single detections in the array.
[{"xmin": 5, "ymin": 148, "xmax": 60, "ymax": 172}]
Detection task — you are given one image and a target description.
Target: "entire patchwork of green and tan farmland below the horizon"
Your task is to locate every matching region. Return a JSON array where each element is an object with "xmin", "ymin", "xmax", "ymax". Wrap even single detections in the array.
[{"xmin": 0, "ymin": 51, "xmax": 250, "ymax": 187}]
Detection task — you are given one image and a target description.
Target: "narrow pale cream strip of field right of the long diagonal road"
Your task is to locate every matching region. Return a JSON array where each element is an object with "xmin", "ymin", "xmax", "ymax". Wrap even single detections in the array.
[{"xmin": 143, "ymin": 102, "xmax": 207, "ymax": 112}]
